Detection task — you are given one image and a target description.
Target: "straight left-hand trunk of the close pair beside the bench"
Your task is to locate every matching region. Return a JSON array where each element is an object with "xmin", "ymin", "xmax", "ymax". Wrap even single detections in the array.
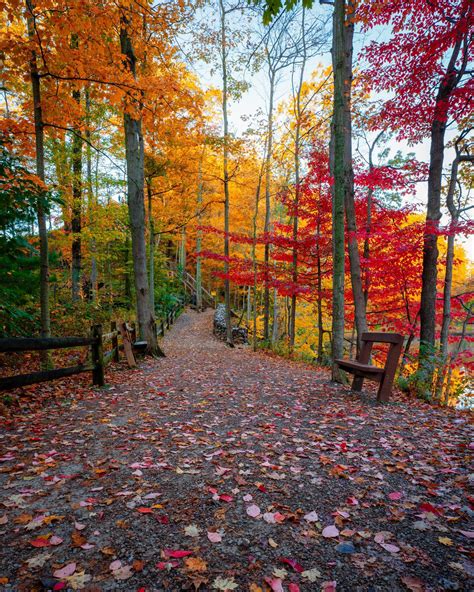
[{"xmin": 329, "ymin": 0, "xmax": 346, "ymax": 382}]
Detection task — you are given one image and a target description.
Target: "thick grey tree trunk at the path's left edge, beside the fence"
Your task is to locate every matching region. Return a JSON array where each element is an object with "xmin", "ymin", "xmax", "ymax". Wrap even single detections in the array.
[{"xmin": 120, "ymin": 15, "xmax": 164, "ymax": 355}]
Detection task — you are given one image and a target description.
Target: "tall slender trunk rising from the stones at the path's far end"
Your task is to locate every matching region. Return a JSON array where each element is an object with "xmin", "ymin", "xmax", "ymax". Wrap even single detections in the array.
[{"xmin": 219, "ymin": 0, "xmax": 234, "ymax": 347}]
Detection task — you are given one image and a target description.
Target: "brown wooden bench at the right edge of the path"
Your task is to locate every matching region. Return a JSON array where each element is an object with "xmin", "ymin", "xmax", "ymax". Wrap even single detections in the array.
[{"xmin": 335, "ymin": 333, "xmax": 404, "ymax": 403}]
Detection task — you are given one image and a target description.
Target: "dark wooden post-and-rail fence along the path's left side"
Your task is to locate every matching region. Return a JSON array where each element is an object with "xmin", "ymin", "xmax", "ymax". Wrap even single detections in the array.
[{"xmin": 0, "ymin": 304, "xmax": 183, "ymax": 391}]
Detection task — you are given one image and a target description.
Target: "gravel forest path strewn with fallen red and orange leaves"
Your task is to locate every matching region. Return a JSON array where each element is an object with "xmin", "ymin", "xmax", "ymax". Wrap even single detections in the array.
[{"xmin": 0, "ymin": 311, "xmax": 473, "ymax": 592}]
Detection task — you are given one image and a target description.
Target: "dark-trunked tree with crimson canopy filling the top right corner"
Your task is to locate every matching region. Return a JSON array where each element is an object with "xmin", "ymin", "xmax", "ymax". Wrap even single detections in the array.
[{"xmin": 358, "ymin": 0, "xmax": 473, "ymax": 364}]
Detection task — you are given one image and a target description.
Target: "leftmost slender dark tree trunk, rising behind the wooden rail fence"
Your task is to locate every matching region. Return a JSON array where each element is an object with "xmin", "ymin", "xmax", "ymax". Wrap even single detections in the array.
[{"xmin": 26, "ymin": 0, "xmax": 51, "ymax": 366}]
